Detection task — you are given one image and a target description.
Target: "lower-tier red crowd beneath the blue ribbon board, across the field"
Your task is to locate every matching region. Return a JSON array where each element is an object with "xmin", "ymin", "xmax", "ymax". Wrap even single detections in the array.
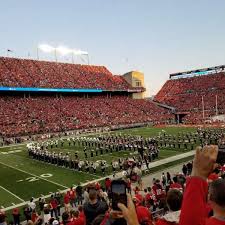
[{"xmin": 0, "ymin": 95, "xmax": 172, "ymax": 137}]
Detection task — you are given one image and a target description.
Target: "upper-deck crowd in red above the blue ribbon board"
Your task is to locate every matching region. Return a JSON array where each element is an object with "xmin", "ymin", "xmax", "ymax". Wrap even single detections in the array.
[{"xmin": 0, "ymin": 57, "xmax": 135, "ymax": 90}]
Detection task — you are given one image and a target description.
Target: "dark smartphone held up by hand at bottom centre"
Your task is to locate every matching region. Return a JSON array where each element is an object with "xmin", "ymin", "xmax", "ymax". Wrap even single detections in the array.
[{"xmin": 111, "ymin": 180, "xmax": 127, "ymax": 211}]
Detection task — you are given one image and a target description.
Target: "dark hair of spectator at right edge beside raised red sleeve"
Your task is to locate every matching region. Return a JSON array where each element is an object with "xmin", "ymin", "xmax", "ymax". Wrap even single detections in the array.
[{"xmin": 209, "ymin": 179, "xmax": 225, "ymax": 207}]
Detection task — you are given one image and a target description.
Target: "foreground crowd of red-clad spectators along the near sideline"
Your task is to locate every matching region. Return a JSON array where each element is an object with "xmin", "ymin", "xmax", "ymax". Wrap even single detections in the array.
[{"xmin": 0, "ymin": 146, "xmax": 225, "ymax": 225}]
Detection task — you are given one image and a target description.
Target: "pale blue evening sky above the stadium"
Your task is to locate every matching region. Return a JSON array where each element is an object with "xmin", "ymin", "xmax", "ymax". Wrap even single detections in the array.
[{"xmin": 0, "ymin": 0, "xmax": 225, "ymax": 96}]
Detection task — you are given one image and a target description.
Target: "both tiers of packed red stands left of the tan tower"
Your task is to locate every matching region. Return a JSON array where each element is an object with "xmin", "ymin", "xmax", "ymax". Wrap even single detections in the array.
[{"xmin": 0, "ymin": 57, "xmax": 172, "ymax": 137}]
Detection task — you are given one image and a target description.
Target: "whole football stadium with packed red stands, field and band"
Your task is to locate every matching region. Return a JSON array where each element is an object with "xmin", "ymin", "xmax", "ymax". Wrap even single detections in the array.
[{"xmin": 0, "ymin": 1, "xmax": 225, "ymax": 225}]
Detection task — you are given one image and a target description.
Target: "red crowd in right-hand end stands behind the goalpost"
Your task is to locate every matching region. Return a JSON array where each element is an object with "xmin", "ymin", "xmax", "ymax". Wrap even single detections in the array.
[{"xmin": 154, "ymin": 72, "xmax": 225, "ymax": 123}]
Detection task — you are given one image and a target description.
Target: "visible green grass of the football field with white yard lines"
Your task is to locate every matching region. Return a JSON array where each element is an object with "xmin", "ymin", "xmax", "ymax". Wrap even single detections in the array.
[{"xmin": 0, "ymin": 127, "xmax": 196, "ymax": 208}]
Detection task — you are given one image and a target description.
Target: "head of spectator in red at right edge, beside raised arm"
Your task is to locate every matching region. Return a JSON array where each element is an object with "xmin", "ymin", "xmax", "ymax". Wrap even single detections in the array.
[{"xmin": 209, "ymin": 179, "xmax": 225, "ymax": 214}]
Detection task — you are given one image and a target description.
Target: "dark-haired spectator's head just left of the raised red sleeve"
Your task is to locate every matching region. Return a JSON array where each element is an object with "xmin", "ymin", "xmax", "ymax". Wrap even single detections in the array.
[{"xmin": 166, "ymin": 189, "xmax": 183, "ymax": 211}]
